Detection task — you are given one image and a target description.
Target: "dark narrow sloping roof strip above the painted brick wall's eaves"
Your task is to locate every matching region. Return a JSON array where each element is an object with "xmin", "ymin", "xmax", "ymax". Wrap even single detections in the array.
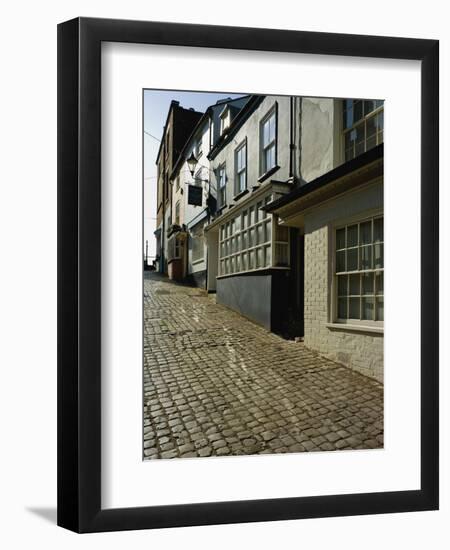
[{"xmin": 263, "ymin": 144, "xmax": 384, "ymax": 212}]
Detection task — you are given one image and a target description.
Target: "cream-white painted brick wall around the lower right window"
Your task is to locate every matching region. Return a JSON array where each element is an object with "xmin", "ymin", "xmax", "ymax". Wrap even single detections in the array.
[{"xmin": 304, "ymin": 181, "xmax": 384, "ymax": 382}]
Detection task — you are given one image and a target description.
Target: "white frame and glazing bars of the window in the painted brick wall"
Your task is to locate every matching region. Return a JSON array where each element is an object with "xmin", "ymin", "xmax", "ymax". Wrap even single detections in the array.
[{"xmin": 331, "ymin": 215, "xmax": 384, "ymax": 329}]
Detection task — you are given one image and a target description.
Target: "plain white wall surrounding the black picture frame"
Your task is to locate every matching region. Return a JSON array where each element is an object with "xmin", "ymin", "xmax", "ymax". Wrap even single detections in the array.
[{"xmin": 0, "ymin": 0, "xmax": 450, "ymax": 550}]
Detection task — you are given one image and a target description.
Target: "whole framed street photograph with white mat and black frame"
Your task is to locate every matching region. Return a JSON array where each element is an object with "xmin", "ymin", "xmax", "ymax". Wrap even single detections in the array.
[{"xmin": 58, "ymin": 18, "xmax": 439, "ymax": 532}]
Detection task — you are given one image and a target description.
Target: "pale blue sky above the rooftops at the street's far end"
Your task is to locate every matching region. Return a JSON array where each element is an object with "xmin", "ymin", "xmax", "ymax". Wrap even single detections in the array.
[{"xmin": 144, "ymin": 90, "xmax": 243, "ymax": 262}]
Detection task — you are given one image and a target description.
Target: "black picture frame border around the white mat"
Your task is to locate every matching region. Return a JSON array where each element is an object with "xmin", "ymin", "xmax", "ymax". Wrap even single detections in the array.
[{"xmin": 58, "ymin": 18, "xmax": 439, "ymax": 532}]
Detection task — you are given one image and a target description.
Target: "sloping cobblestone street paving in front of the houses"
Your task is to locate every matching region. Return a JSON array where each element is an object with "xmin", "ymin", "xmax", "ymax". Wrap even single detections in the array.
[{"xmin": 144, "ymin": 274, "xmax": 383, "ymax": 459}]
